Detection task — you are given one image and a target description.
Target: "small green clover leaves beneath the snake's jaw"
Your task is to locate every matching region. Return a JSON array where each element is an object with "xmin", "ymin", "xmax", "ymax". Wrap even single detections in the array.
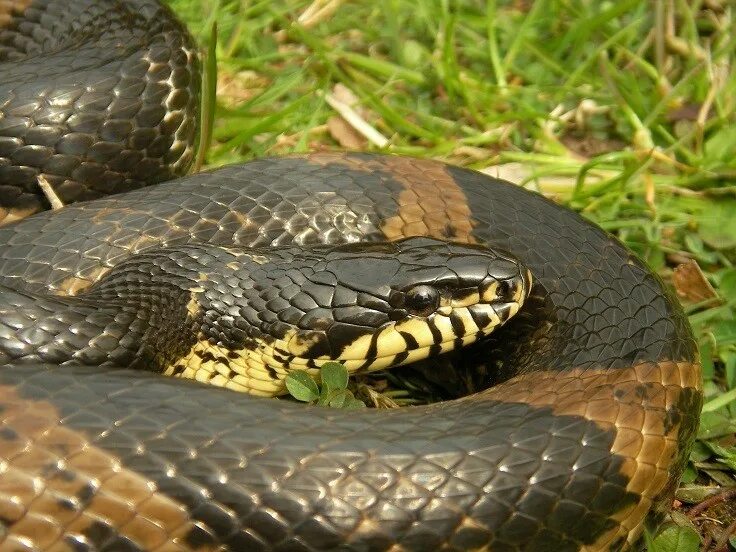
[{"xmin": 286, "ymin": 362, "xmax": 365, "ymax": 408}]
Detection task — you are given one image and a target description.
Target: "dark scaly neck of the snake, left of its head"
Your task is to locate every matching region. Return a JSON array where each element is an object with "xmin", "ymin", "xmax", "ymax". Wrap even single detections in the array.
[{"xmin": 0, "ymin": 248, "xmax": 249, "ymax": 372}]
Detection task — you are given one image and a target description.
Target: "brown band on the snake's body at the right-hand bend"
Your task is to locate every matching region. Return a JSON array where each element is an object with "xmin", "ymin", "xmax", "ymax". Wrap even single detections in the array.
[{"xmin": 480, "ymin": 361, "xmax": 702, "ymax": 550}]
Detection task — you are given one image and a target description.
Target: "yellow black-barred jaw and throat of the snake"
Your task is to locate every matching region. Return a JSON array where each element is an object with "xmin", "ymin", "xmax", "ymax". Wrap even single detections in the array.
[{"xmin": 162, "ymin": 256, "xmax": 530, "ymax": 396}]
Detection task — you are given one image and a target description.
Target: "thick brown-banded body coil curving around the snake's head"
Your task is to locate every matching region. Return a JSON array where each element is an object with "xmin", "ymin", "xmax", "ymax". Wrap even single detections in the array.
[{"xmin": 0, "ymin": 0, "xmax": 702, "ymax": 551}]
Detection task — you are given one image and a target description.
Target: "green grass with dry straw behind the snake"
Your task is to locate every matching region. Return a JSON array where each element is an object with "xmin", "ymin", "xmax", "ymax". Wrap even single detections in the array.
[{"xmin": 164, "ymin": 0, "xmax": 736, "ymax": 550}]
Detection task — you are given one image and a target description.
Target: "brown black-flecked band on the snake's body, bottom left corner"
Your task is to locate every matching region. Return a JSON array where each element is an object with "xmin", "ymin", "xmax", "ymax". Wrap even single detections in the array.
[{"xmin": 0, "ymin": 385, "xmax": 215, "ymax": 551}]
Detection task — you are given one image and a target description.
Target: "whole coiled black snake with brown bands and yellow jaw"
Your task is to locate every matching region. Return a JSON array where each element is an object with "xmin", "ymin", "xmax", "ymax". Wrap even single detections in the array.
[{"xmin": 0, "ymin": 0, "xmax": 702, "ymax": 552}]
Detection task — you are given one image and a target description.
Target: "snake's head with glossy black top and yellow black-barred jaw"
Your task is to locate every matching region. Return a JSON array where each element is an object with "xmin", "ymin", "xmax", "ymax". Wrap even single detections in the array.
[{"xmin": 175, "ymin": 237, "xmax": 531, "ymax": 395}]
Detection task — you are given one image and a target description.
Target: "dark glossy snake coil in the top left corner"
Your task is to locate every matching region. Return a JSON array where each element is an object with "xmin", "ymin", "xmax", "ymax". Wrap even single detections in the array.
[{"xmin": 0, "ymin": 0, "xmax": 200, "ymax": 215}]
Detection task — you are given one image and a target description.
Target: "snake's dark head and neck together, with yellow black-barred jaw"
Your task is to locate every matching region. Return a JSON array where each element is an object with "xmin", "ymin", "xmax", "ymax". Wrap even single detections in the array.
[{"xmin": 0, "ymin": 237, "xmax": 530, "ymax": 396}]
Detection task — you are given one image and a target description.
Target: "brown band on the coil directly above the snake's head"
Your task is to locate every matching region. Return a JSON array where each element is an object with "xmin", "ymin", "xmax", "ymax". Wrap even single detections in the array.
[{"xmin": 308, "ymin": 152, "xmax": 477, "ymax": 243}]
